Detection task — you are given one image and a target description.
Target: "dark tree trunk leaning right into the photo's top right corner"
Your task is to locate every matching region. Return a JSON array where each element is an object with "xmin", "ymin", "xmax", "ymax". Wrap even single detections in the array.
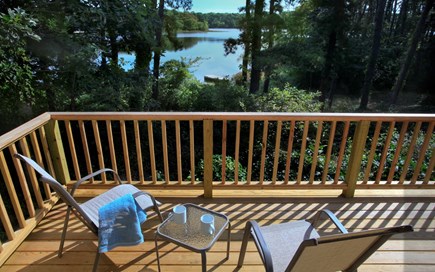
[{"xmin": 391, "ymin": 0, "xmax": 434, "ymax": 104}]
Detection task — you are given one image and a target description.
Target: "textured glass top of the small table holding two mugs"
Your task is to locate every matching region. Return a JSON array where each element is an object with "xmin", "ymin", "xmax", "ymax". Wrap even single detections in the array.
[{"xmin": 157, "ymin": 204, "xmax": 228, "ymax": 250}]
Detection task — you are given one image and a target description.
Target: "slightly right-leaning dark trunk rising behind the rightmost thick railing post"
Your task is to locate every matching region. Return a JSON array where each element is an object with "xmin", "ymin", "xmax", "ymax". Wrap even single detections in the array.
[{"xmin": 359, "ymin": 0, "xmax": 386, "ymax": 110}]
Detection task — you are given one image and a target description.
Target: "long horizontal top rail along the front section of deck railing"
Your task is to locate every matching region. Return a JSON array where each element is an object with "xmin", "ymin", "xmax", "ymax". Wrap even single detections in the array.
[{"xmin": 49, "ymin": 112, "xmax": 435, "ymax": 122}]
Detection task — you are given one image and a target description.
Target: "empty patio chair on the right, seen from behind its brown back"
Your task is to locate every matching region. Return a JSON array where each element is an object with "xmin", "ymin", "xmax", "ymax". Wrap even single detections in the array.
[{"xmin": 237, "ymin": 209, "xmax": 413, "ymax": 272}]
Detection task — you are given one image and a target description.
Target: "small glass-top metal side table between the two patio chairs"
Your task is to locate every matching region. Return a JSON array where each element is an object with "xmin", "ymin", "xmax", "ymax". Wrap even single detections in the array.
[{"xmin": 154, "ymin": 203, "xmax": 231, "ymax": 271}]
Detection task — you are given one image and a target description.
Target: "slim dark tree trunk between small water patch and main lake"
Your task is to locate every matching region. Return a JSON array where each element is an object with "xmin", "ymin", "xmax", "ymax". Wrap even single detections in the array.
[{"xmin": 152, "ymin": 0, "xmax": 165, "ymax": 99}]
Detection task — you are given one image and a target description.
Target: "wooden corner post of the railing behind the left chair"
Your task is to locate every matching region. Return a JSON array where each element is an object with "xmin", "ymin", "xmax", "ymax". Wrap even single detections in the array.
[{"xmin": 45, "ymin": 120, "xmax": 71, "ymax": 184}]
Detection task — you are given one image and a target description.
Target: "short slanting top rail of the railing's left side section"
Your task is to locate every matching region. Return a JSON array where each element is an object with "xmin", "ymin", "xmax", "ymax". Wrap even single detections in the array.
[{"xmin": 0, "ymin": 113, "xmax": 51, "ymax": 150}]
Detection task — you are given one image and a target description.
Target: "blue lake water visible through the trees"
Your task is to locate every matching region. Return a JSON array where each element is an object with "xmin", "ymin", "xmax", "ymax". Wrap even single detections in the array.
[{"xmin": 119, "ymin": 28, "xmax": 243, "ymax": 81}]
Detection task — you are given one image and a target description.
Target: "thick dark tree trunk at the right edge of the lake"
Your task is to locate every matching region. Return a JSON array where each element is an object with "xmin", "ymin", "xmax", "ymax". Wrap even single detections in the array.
[{"xmin": 249, "ymin": 0, "xmax": 264, "ymax": 93}]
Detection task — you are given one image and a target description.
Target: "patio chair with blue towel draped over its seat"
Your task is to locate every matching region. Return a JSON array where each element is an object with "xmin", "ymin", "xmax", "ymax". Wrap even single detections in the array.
[{"xmin": 15, "ymin": 154, "xmax": 163, "ymax": 271}]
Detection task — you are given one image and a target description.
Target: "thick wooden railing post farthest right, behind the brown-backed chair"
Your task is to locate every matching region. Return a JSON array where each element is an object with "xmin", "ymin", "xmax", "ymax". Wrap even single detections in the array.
[{"xmin": 342, "ymin": 121, "xmax": 370, "ymax": 198}]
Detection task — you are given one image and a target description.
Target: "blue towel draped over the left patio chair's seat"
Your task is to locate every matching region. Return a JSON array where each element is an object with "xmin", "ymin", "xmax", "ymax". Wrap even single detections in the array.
[{"xmin": 98, "ymin": 194, "xmax": 146, "ymax": 253}]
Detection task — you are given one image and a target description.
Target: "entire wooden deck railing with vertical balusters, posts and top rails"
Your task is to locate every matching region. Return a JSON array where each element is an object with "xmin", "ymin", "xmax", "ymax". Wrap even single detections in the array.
[{"xmin": 0, "ymin": 113, "xmax": 435, "ymax": 265}]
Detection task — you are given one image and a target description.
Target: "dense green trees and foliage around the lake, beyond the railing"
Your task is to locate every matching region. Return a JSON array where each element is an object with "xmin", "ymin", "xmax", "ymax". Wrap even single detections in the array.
[{"xmin": 0, "ymin": 0, "xmax": 435, "ymax": 134}]
